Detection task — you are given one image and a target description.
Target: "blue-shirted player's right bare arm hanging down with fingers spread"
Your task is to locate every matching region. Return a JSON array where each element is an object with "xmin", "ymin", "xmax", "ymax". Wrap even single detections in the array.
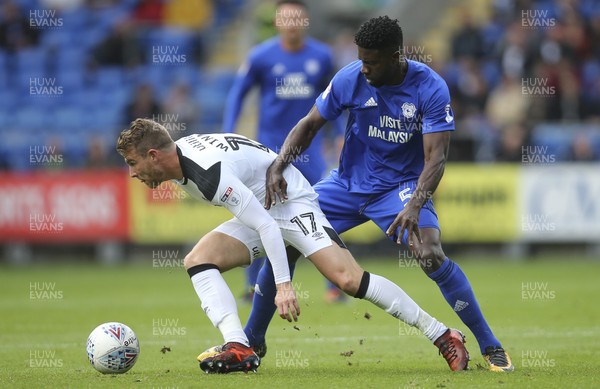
[{"xmin": 386, "ymin": 131, "xmax": 450, "ymax": 245}]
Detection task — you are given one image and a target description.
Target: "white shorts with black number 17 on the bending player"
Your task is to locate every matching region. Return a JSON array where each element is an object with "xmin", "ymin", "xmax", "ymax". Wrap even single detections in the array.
[{"xmin": 214, "ymin": 198, "xmax": 339, "ymax": 261}]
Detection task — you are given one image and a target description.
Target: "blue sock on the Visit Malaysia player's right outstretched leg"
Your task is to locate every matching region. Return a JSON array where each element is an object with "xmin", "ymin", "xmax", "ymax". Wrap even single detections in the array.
[{"xmin": 429, "ymin": 258, "xmax": 501, "ymax": 354}]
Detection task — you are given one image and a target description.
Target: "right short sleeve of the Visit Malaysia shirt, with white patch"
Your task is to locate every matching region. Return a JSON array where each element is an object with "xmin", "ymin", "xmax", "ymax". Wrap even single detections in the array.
[{"xmin": 423, "ymin": 78, "xmax": 454, "ymax": 134}]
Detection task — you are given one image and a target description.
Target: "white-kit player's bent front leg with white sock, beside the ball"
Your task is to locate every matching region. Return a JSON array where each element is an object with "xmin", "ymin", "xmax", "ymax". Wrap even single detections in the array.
[{"xmin": 184, "ymin": 222, "xmax": 260, "ymax": 373}]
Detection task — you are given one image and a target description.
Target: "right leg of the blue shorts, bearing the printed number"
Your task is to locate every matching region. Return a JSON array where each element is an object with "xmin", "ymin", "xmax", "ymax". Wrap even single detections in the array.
[{"xmin": 365, "ymin": 181, "xmax": 440, "ymax": 245}]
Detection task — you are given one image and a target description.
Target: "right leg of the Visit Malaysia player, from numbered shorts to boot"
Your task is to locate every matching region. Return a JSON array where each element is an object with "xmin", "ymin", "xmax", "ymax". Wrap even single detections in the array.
[{"xmin": 366, "ymin": 183, "xmax": 513, "ymax": 371}]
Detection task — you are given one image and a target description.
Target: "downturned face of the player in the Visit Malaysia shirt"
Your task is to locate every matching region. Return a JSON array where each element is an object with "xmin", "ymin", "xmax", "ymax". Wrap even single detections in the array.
[{"xmin": 358, "ymin": 47, "xmax": 399, "ymax": 88}]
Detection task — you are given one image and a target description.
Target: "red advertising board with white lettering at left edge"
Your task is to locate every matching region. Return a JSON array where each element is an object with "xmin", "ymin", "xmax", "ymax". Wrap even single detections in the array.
[{"xmin": 0, "ymin": 170, "xmax": 129, "ymax": 243}]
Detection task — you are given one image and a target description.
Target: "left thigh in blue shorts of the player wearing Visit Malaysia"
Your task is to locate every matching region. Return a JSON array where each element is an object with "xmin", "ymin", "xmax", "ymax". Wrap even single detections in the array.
[{"xmin": 313, "ymin": 176, "xmax": 369, "ymax": 234}]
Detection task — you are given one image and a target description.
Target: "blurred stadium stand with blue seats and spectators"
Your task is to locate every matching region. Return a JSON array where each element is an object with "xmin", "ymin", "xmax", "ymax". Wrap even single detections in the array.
[{"xmin": 0, "ymin": 0, "xmax": 600, "ymax": 170}]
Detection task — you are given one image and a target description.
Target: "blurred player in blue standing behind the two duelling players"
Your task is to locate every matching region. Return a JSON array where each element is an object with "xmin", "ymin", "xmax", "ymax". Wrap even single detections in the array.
[{"xmin": 223, "ymin": 0, "xmax": 345, "ymax": 302}]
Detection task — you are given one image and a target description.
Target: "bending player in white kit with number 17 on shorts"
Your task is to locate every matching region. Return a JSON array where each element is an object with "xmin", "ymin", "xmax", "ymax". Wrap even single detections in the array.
[{"xmin": 117, "ymin": 119, "xmax": 469, "ymax": 373}]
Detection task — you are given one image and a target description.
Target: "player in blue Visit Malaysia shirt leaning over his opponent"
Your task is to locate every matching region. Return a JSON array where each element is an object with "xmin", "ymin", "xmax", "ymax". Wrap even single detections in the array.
[{"xmin": 237, "ymin": 16, "xmax": 514, "ymax": 372}]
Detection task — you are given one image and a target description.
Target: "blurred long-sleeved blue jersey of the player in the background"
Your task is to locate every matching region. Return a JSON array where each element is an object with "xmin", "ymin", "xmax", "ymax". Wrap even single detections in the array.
[{"xmin": 223, "ymin": 37, "xmax": 333, "ymax": 174}]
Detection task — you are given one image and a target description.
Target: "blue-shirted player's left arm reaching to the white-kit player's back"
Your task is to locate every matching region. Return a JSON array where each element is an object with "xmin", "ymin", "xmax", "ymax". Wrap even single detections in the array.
[{"xmin": 264, "ymin": 105, "xmax": 327, "ymax": 209}]
